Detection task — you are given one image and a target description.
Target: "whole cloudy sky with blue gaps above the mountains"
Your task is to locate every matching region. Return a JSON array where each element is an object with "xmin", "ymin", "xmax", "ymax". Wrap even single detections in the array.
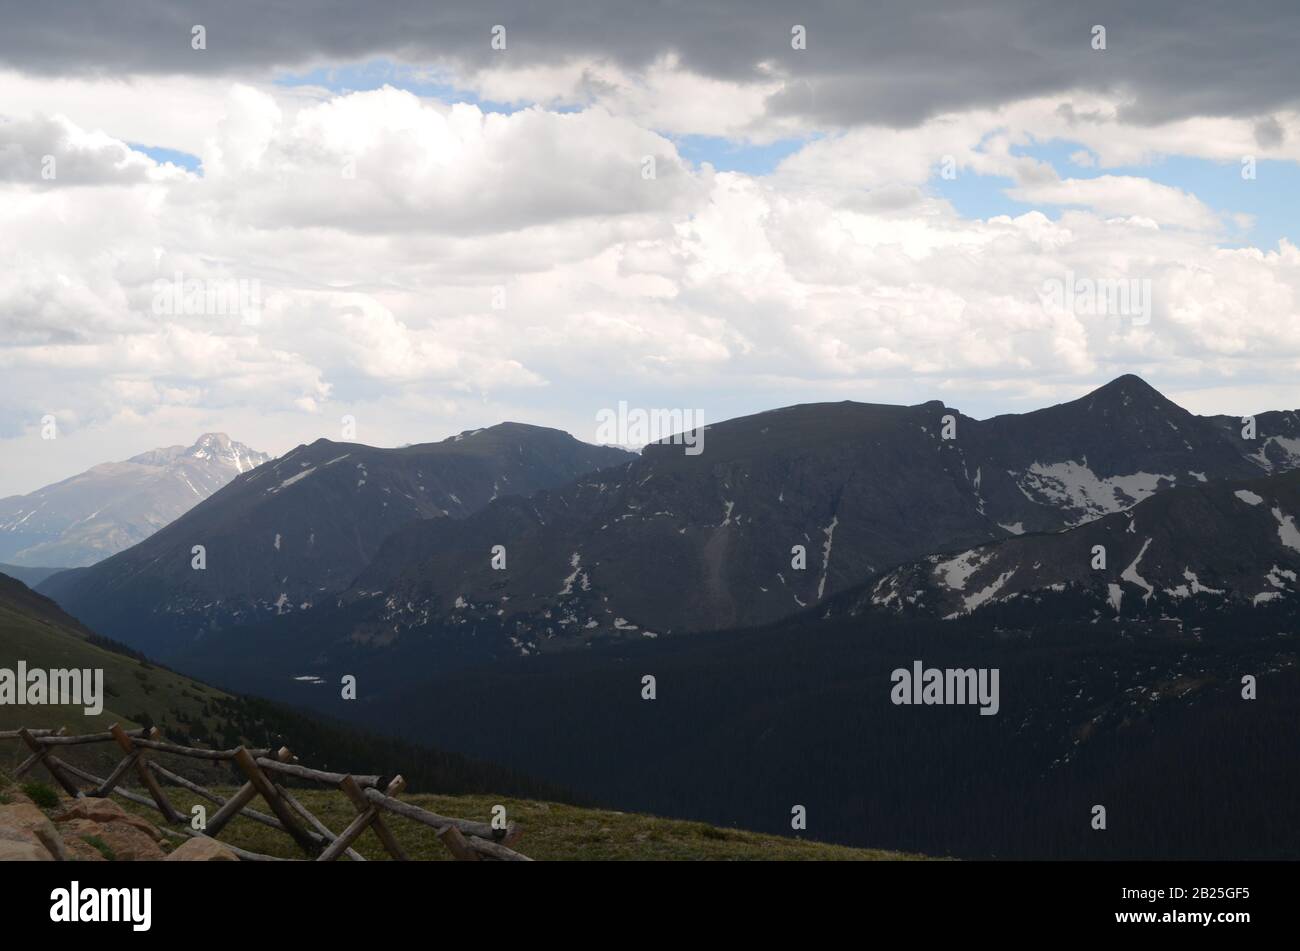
[{"xmin": 0, "ymin": 0, "xmax": 1300, "ymax": 495}]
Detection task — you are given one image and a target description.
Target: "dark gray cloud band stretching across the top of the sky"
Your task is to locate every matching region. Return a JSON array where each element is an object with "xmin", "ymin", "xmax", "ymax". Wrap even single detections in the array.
[{"xmin": 0, "ymin": 0, "xmax": 1300, "ymax": 126}]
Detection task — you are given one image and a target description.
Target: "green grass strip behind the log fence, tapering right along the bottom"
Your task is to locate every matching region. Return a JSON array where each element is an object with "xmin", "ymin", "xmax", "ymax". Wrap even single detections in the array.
[{"xmin": 111, "ymin": 787, "xmax": 926, "ymax": 861}]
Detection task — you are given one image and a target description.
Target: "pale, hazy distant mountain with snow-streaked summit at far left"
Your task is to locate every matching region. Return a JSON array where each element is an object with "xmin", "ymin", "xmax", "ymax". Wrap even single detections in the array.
[{"xmin": 0, "ymin": 433, "xmax": 270, "ymax": 568}]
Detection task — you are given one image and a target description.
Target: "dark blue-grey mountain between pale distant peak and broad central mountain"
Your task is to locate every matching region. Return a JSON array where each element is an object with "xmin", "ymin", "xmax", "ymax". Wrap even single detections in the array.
[{"xmin": 40, "ymin": 424, "xmax": 631, "ymax": 656}]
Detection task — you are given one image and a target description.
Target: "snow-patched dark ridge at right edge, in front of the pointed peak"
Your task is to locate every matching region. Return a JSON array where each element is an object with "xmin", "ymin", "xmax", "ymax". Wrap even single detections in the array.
[{"xmin": 828, "ymin": 470, "xmax": 1300, "ymax": 630}]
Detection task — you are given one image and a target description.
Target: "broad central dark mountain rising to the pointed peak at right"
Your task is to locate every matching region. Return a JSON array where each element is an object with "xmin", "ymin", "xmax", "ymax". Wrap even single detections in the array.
[{"xmin": 236, "ymin": 377, "xmax": 1296, "ymax": 657}]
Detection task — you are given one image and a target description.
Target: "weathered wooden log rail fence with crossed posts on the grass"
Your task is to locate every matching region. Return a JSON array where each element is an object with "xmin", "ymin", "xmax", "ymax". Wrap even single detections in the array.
[{"xmin": 0, "ymin": 724, "xmax": 532, "ymax": 861}]
